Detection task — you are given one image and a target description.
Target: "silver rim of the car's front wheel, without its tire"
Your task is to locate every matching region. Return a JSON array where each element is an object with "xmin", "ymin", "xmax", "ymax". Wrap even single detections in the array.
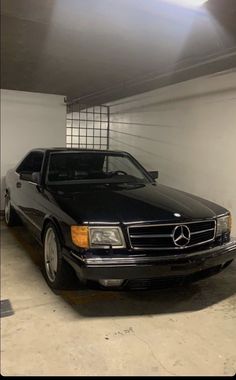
[{"xmin": 44, "ymin": 227, "xmax": 58, "ymax": 282}]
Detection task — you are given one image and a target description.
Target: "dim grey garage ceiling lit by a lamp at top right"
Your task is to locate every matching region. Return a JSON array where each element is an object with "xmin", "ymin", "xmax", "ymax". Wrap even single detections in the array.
[{"xmin": 1, "ymin": 0, "xmax": 236, "ymax": 104}]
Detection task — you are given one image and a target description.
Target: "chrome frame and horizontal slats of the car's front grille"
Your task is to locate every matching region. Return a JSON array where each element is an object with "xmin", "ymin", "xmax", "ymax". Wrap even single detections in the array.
[{"xmin": 127, "ymin": 219, "xmax": 216, "ymax": 251}]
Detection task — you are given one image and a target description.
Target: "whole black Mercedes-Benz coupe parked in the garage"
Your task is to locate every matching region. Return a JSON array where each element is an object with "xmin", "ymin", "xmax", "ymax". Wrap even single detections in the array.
[{"xmin": 5, "ymin": 148, "xmax": 236, "ymax": 288}]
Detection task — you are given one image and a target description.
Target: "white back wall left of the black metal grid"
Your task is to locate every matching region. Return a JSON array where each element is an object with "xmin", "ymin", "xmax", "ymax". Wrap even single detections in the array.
[{"xmin": 1, "ymin": 90, "xmax": 66, "ymax": 209}]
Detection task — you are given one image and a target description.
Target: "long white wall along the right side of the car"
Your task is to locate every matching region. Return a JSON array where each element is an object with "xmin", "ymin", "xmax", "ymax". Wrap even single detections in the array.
[{"xmin": 110, "ymin": 71, "xmax": 236, "ymax": 235}]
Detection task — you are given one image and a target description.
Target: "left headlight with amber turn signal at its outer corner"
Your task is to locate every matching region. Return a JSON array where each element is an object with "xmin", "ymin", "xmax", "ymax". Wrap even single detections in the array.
[{"xmin": 71, "ymin": 226, "xmax": 125, "ymax": 248}]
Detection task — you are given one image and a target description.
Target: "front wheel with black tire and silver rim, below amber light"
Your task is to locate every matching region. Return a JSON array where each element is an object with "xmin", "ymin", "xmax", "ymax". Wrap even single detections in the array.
[{"xmin": 43, "ymin": 222, "xmax": 75, "ymax": 290}]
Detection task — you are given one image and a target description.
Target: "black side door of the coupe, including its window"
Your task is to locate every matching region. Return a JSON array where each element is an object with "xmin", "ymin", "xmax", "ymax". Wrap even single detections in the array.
[{"xmin": 15, "ymin": 151, "xmax": 45, "ymax": 236}]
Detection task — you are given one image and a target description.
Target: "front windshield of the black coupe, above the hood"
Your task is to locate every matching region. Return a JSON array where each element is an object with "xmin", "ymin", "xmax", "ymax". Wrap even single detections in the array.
[{"xmin": 46, "ymin": 152, "xmax": 151, "ymax": 185}]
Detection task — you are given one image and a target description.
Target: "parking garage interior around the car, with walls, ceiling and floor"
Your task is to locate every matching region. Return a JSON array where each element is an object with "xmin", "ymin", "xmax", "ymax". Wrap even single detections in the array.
[{"xmin": 1, "ymin": 0, "xmax": 236, "ymax": 376}]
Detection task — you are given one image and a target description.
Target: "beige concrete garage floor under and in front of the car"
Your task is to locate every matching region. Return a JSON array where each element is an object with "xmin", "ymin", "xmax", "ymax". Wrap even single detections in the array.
[{"xmin": 1, "ymin": 224, "xmax": 236, "ymax": 376}]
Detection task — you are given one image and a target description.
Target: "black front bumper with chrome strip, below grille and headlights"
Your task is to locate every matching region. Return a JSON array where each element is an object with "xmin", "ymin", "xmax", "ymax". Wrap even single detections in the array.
[{"xmin": 64, "ymin": 240, "xmax": 236, "ymax": 281}]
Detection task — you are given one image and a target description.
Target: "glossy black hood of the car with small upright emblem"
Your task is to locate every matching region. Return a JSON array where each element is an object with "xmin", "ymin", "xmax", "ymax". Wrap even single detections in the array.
[{"xmin": 49, "ymin": 184, "xmax": 227, "ymax": 224}]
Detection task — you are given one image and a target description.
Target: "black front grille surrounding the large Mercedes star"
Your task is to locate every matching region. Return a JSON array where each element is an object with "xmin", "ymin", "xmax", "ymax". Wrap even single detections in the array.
[{"xmin": 128, "ymin": 220, "xmax": 216, "ymax": 250}]
